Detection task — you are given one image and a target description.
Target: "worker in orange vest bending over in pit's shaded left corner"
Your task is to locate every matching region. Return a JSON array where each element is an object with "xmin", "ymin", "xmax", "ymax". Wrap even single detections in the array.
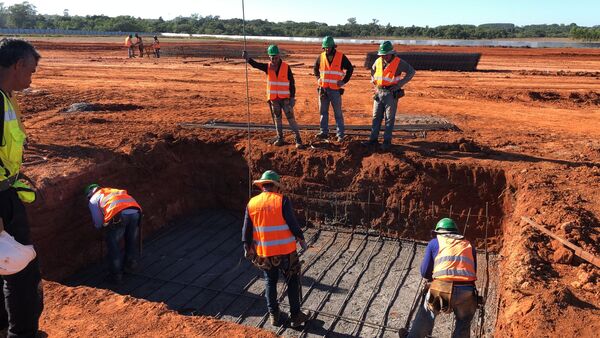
[{"xmin": 84, "ymin": 183, "xmax": 142, "ymax": 284}]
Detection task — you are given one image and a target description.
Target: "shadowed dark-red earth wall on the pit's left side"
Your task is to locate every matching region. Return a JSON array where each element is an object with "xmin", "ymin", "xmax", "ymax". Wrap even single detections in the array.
[{"xmin": 28, "ymin": 139, "xmax": 248, "ymax": 281}]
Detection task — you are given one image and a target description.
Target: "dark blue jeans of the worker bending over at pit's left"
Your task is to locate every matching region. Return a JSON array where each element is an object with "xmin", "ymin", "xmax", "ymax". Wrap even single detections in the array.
[{"xmin": 106, "ymin": 212, "xmax": 140, "ymax": 274}]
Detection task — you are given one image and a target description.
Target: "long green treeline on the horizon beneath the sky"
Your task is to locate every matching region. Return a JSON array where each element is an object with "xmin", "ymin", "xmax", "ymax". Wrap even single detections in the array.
[{"xmin": 0, "ymin": 2, "xmax": 600, "ymax": 41}]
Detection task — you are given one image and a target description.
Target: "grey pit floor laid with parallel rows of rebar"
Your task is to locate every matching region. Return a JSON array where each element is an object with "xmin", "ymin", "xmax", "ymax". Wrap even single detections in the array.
[{"xmin": 69, "ymin": 211, "xmax": 497, "ymax": 337}]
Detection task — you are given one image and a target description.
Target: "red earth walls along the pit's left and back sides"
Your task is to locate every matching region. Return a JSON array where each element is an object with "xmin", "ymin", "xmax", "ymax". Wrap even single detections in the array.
[{"xmin": 29, "ymin": 137, "xmax": 512, "ymax": 280}]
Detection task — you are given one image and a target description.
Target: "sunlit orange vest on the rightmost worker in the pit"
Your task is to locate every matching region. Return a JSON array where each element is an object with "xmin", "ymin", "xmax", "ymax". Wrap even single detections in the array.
[{"xmin": 433, "ymin": 235, "xmax": 477, "ymax": 282}]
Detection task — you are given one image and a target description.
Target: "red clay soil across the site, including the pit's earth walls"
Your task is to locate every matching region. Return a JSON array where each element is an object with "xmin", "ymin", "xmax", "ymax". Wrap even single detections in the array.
[{"xmin": 10, "ymin": 39, "xmax": 600, "ymax": 337}]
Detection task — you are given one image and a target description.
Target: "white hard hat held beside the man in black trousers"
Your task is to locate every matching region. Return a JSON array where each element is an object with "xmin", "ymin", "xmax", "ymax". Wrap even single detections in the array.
[{"xmin": 0, "ymin": 231, "xmax": 36, "ymax": 276}]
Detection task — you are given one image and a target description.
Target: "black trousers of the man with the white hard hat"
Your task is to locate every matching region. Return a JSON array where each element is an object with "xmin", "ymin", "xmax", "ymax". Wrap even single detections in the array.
[{"xmin": 0, "ymin": 188, "xmax": 44, "ymax": 337}]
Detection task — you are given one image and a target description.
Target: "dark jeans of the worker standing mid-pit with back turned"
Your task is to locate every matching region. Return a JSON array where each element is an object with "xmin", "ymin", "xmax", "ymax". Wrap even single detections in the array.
[{"xmin": 263, "ymin": 256, "xmax": 300, "ymax": 317}]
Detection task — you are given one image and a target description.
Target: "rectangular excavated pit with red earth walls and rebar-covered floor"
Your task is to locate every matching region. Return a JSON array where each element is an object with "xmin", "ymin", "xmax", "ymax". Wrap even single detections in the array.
[{"xmin": 55, "ymin": 136, "xmax": 513, "ymax": 337}]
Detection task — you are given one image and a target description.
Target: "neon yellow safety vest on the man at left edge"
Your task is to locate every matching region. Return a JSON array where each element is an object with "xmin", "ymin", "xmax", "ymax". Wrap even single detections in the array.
[{"xmin": 0, "ymin": 91, "xmax": 26, "ymax": 181}]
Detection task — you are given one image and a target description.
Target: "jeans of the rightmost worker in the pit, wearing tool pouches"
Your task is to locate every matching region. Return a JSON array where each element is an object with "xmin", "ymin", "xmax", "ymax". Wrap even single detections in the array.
[{"xmin": 408, "ymin": 285, "xmax": 477, "ymax": 338}]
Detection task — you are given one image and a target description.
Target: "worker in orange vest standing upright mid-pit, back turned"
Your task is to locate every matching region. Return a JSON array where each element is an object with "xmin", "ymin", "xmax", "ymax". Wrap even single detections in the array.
[{"xmin": 242, "ymin": 170, "xmax": 309, "ymax": 328}]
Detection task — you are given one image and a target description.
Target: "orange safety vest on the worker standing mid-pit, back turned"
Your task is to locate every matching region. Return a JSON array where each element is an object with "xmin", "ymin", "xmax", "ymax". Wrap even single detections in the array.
[{"xmin": 248, "ymin": 191, "xmax": 296, "ymax": 257}]
